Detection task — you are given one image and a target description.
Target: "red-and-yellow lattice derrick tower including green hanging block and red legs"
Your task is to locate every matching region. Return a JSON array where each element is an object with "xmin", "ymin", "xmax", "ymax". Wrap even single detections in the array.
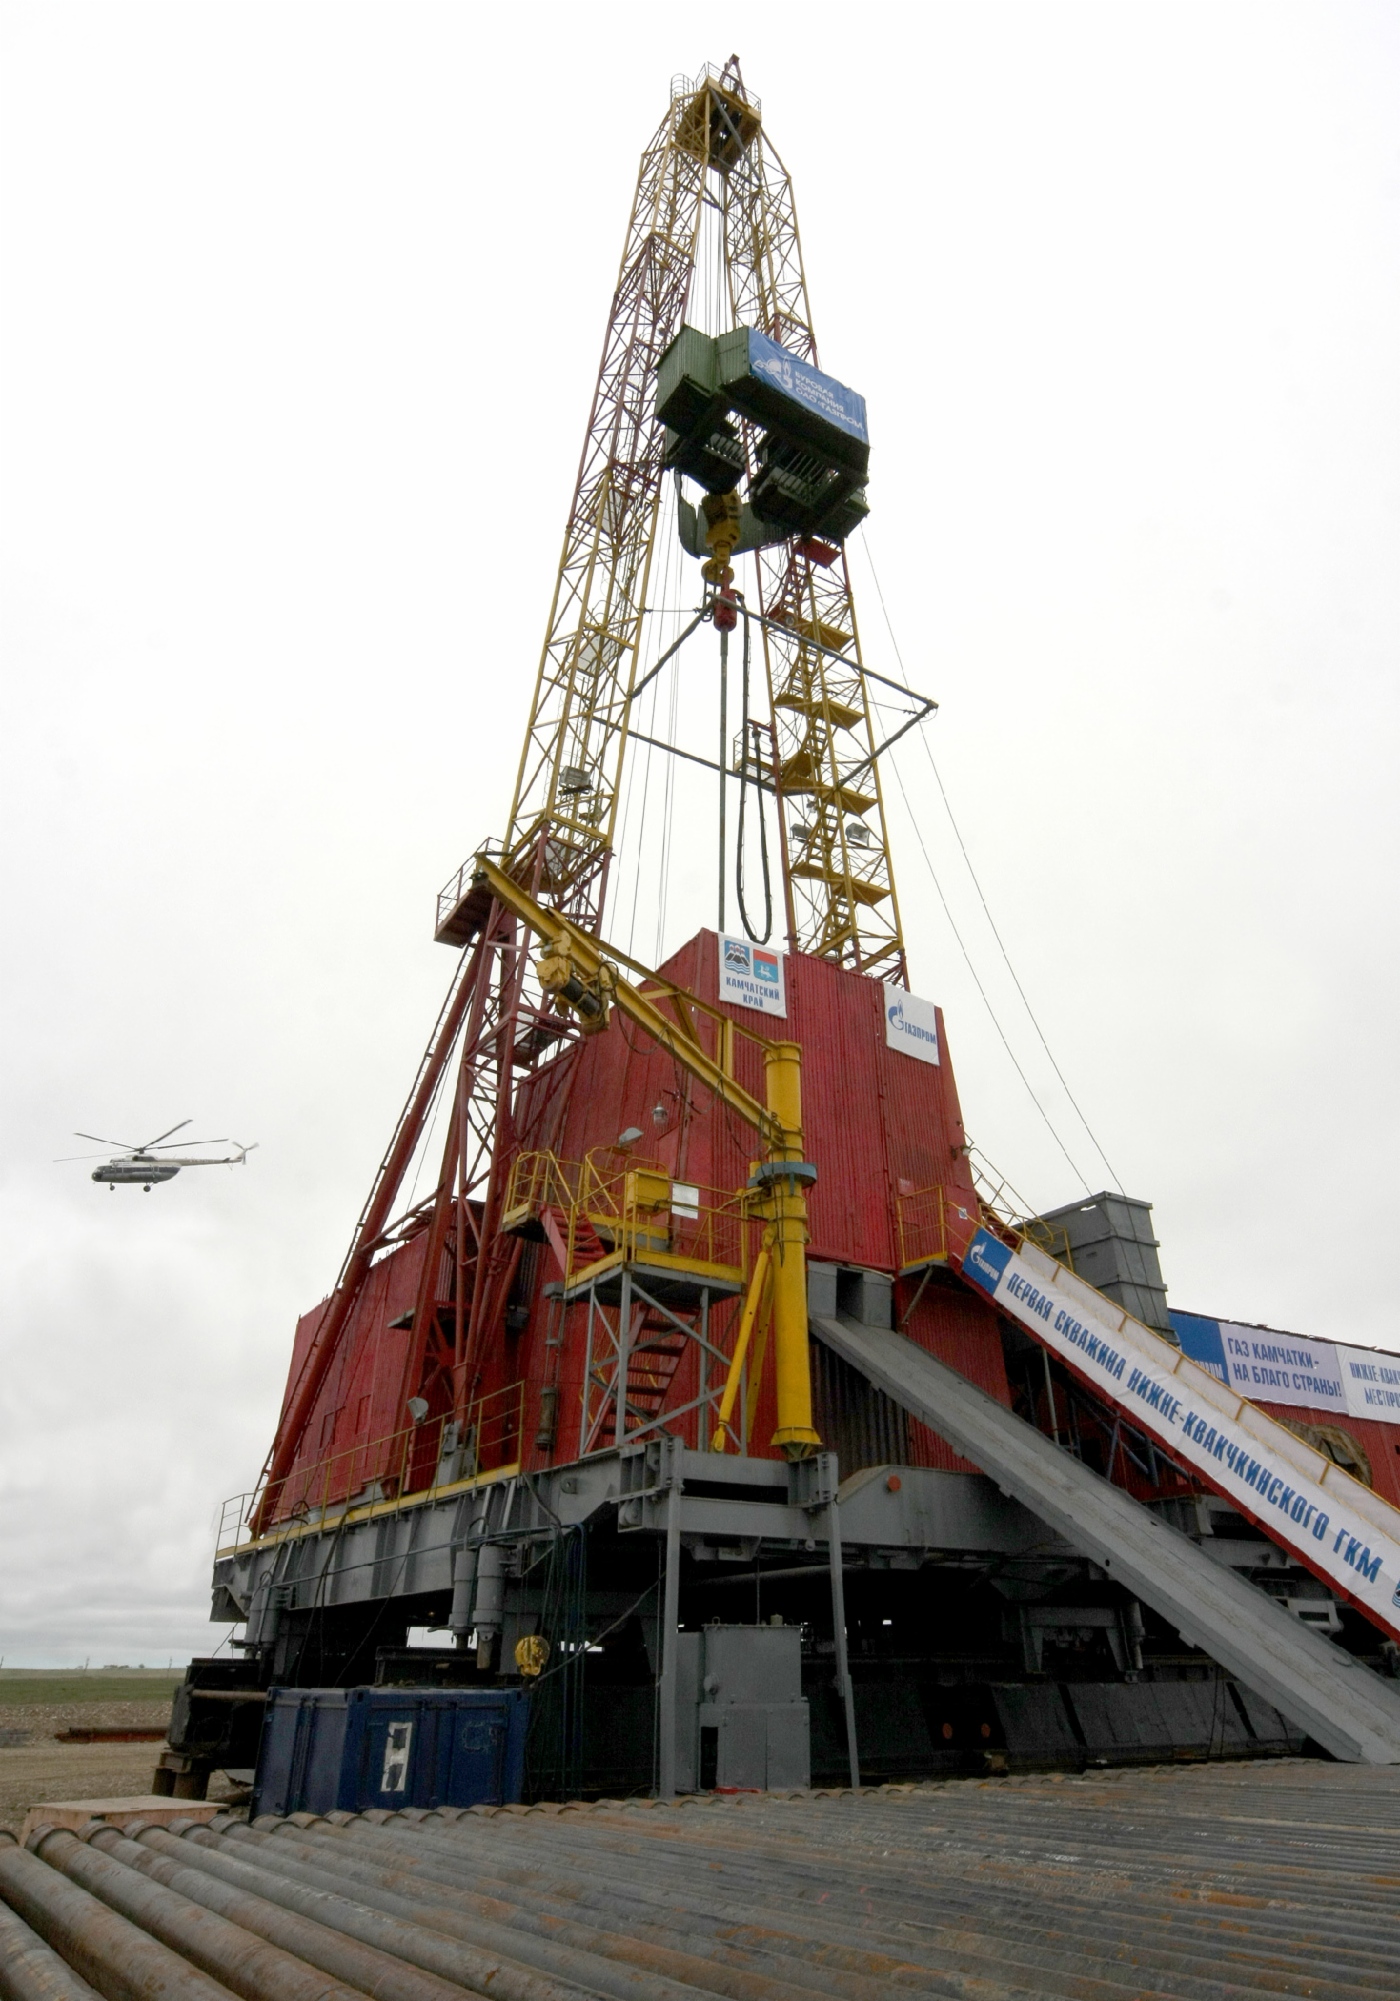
[{"xmin": 266, "ymin": 56, "xmax": 920, "ymax": 1528}]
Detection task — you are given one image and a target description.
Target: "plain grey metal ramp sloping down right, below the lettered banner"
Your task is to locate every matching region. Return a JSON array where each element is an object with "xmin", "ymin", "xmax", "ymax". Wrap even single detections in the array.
[{"xmin": 812, "ymin": 1315, "xmax": 1400, "ymax": 1765}]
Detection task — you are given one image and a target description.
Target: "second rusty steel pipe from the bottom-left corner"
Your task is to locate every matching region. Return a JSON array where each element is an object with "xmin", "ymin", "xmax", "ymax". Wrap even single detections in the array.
[{"xmin": 0, "ymin": 1843, "xmax": 228, "ymax": 2001}]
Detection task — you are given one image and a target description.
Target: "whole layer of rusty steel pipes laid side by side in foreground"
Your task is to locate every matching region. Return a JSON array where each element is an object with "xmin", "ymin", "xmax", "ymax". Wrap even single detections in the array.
[{"xmin": 0, "ymin": 1759, "xmax": 1400, "ymax": 2001}]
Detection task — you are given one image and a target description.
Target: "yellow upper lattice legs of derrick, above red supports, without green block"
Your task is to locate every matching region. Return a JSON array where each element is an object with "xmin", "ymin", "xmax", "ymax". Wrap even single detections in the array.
[{"xmin": 504, "ymin": 58, "xmax": 904, "ymax": 980}]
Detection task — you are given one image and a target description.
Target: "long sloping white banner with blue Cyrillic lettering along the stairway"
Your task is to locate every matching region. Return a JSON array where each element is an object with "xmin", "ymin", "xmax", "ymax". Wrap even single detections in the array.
[{"xmin": 962, "ymin": 1231, "xmax": 1400, "ymax": 1639}]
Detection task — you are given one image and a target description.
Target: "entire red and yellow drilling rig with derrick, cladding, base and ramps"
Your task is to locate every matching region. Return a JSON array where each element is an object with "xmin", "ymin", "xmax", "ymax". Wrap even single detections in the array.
[{"xmin": 175, "ymin": 58, "xmax": 1400, "ymax": 1799}]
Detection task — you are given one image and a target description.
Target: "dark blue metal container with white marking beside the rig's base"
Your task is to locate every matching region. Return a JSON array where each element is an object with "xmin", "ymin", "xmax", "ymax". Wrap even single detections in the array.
[{"xmin": 252, "ymin": 1689, "xmax": 530, "ymax": 1815}]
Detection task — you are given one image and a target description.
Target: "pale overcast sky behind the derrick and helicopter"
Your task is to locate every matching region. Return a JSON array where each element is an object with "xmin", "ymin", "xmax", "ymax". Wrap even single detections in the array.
[{"xmin": 0, "ymin": 0, "xmax": 1400, "ymax": 1665}]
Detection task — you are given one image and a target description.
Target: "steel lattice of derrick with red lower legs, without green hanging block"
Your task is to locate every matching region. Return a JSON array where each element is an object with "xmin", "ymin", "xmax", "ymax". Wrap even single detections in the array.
[{"xmin": 266, "ymin": 58, "xmax": 906, "ymax": 1487}]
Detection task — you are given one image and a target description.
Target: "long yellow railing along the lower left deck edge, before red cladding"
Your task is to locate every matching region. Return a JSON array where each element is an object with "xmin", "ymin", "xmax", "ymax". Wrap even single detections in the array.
[{"xmin": 216, "ymin": 1383, "xmax": 526, "ymax": 1553}]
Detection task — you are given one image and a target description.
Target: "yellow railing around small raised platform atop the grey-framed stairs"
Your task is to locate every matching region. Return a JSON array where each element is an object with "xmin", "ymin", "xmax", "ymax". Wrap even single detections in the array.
[{"xmin": 502, "ymin": 1147, "xmax": 750, "ymax": 1285}]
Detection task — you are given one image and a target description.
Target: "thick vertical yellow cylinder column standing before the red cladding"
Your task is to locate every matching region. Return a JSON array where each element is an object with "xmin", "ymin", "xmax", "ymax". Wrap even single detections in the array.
[{"xmin": 762, "ymin": 1043, "xmax": 822, "ymax": 1459}]
